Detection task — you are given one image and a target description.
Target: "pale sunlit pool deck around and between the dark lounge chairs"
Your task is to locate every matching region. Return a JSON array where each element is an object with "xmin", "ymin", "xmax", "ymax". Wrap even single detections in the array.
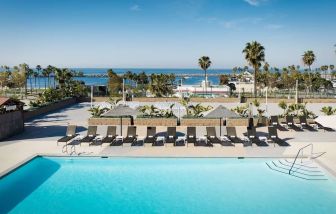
[{"xmin": 0, "ymin": 103, "xmax": 336, "ymax": 176}]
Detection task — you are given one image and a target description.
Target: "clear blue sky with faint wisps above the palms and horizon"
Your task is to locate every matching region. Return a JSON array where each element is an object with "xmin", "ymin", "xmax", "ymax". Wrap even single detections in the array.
[{"xmin": 0, "ymin": 0, "xmax": 336, "ymax": 68}]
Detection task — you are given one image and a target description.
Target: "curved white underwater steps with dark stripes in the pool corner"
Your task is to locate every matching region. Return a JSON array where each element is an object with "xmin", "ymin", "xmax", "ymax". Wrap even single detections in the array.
[{"xmin": 266, "ymin": 160, "xmax": 328, "ymax": 180}]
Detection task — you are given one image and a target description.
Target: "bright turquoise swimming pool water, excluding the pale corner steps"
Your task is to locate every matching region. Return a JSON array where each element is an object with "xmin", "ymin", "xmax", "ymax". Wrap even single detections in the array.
[{"xmin": 0, "ymin": 157, "xmax": 336, "ymax": 214}]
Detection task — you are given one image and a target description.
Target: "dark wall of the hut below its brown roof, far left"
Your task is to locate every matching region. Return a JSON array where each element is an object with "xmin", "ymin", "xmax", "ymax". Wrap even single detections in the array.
[{"xmin": 0, "ymin": 111, "xmax": 24, "ymax": 140}]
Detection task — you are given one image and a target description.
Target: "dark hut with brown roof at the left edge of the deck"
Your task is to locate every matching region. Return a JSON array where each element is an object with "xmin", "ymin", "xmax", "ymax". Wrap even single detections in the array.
[{"xmin": 0, "ymin": 97, "xmax": 24, "ymax": 140}]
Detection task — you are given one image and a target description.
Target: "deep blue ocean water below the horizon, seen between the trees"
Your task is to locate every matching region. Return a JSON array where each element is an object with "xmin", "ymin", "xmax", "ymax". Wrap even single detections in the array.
[{"xmin": 28, "ymin": 68, "xmax": 231, "ymax": 88}]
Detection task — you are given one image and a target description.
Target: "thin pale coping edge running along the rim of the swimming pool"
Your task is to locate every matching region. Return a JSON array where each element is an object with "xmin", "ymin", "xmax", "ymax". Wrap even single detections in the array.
[{"xmin": 0, "ymin": 153, "xmax": 336, "ymax": 180}]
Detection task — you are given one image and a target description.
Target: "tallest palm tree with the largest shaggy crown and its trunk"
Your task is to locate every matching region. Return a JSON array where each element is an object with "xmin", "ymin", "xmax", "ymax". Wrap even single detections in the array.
[{"xmin": 243, "ymin": 41, "xmax": 265, "ymax": 97}]
